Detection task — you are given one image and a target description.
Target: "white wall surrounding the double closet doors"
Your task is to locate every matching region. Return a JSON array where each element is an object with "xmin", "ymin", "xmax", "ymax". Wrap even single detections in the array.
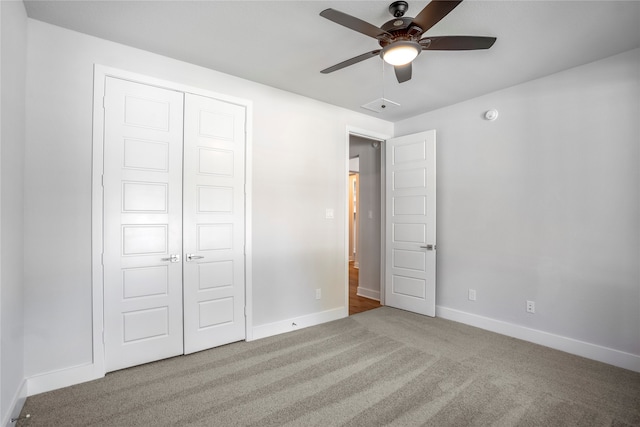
[{"xmin": 25, "ymin": 20, "xmax": 393, "ymax": 377}]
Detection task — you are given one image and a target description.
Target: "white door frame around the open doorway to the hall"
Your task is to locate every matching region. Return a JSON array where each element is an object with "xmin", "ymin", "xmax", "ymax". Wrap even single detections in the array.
[{"xmin": 342, "ymin": 126, "xmax": 393, "ymax": 310}]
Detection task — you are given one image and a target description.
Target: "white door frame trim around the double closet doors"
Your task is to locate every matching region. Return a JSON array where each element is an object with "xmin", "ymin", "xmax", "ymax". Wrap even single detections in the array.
[{"xmin": 91, "ymin": 64, "xmax": 253, "ymax": 378}]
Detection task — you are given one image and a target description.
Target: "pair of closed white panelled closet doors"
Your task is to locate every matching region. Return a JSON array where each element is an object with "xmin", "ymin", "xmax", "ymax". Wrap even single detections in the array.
[{"xmin": 103, "ymin": 77, "xmax": 245, "ymax": 371}]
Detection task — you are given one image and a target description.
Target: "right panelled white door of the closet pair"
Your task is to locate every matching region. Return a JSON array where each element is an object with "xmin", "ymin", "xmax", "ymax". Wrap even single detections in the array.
[{"xmin": 183, "ymin": 94, "xmax": 245, "ymax": 354}]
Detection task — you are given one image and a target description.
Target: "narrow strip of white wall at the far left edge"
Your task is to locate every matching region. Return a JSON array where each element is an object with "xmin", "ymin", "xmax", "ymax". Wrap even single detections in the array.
[{"xmin": 0, "ymin": 1, "xmax": 27, "ymax": 425}]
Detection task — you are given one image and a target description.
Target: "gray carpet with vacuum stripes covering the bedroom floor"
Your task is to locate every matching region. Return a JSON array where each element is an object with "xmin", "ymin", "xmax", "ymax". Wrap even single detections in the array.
[{"xmin": 18, "ymin": 307, "xmax": 640, "ymax": 427}]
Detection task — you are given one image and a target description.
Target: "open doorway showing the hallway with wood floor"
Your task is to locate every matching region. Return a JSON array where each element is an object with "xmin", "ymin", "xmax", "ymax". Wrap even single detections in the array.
[{"xmin": 347, "ymin": 135, "xmax": 382, "ymax": 315}]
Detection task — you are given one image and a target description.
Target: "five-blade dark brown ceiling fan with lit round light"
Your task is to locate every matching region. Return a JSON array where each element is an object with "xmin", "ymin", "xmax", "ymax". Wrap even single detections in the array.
[{"xmin": 320, "ymin": 0, "xmax": 496, "ymax": 83}]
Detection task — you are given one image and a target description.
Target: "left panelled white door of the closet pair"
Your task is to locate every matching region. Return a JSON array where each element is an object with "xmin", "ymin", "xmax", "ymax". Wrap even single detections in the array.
[{"xmin": 103, "ymin": 77, "xmax": 183, "ymax": 371}]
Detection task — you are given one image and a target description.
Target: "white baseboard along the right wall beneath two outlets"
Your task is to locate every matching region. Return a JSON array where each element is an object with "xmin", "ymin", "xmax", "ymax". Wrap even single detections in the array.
[{"xmin": 436, "ymin": 306, "xmax": 640, "ymax": 372}]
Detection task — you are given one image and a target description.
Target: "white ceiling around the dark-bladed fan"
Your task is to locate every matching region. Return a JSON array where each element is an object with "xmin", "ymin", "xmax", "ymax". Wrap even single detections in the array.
[{"xmin": 25, "ymin": 0, "xmax": 640, "ymax": 122}]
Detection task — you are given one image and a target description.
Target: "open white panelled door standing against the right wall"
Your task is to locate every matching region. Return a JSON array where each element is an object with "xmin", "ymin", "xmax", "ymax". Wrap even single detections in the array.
[{"xmin": 385, "ymin": 130, "xmax": 436, "ymax": 316}]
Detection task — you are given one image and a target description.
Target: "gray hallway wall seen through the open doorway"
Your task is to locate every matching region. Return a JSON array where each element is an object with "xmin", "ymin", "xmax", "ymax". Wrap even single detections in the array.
[{"xmin": 349, "ymin": 136, "xmax": 384, "ymax": 300}]
